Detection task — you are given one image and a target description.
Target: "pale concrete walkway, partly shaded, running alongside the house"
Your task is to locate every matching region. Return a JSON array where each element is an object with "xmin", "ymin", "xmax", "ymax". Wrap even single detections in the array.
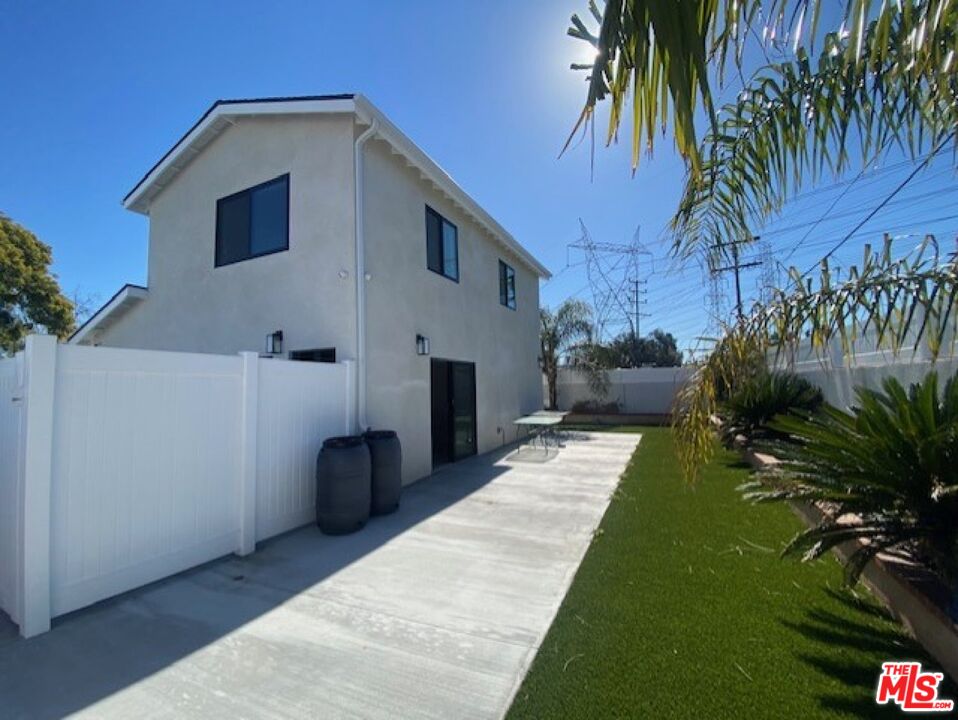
[{"xmin": 0, "ymin": 433, "xmax": 639, "ymax": 720}]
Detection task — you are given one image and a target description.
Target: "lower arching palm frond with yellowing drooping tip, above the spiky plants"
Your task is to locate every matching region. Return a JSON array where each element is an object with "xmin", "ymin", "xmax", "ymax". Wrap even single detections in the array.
[{"xmin": 673, "ymin": 237, "xmax": 958, "ymax": 480}]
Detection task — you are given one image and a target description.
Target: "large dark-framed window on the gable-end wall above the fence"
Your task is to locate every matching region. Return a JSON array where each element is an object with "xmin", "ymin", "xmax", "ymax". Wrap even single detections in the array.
[{"xmin": 216, "ymin": 174, "xmax": 289, "ymax": 267}]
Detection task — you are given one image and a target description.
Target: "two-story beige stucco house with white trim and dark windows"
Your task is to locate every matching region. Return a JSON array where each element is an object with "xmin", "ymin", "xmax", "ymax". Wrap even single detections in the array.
[{"xmin": 71, "ymin": 95, "xmax": 549, "ymax": 483}]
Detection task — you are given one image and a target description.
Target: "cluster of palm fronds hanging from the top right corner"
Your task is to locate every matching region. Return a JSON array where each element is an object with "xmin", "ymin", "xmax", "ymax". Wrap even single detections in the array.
[{"xmin": 569, "ymin": 0, "xmax": 958, "ymax": 254}]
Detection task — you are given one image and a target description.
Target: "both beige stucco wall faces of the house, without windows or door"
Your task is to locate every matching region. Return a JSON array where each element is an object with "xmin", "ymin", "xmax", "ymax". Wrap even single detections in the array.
[{"xmin": 92, "ymin": 116, "xmax": 542, "ymax": 484}]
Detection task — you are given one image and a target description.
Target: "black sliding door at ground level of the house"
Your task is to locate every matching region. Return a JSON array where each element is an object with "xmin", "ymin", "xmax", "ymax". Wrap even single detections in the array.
[{"xmin": 431, "ymin": 360, "xmax": 476, "ymax": 465}]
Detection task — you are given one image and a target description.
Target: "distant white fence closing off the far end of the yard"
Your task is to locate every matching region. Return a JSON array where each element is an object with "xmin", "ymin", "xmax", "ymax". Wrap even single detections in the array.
[{"xmin": 543, "ymin": 367, "xmax": 693, "ymax": 415}]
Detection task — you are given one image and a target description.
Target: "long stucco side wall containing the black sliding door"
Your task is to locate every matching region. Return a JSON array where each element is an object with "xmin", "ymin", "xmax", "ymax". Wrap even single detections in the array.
[{"xmin": 365, "ymin": 136, "xmax": 542, "ymax": 480}]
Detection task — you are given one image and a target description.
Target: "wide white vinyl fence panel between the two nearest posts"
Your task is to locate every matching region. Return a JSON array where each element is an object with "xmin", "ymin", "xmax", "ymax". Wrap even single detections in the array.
[{"xmin": 51, "ymin": 345, "xmax": 241, "ymax": 616}]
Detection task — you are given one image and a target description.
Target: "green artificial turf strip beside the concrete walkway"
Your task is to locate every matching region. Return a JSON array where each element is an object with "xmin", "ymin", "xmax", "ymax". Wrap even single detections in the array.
[{"xmin": 508, "ymin": 428, "xmax": 958, "ymax": 720}]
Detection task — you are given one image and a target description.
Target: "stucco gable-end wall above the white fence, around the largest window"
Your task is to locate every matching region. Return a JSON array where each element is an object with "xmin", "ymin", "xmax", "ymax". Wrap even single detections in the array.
[{"xmin": 94, "ymin": 115, "xmax": 356, "ymax": 357}]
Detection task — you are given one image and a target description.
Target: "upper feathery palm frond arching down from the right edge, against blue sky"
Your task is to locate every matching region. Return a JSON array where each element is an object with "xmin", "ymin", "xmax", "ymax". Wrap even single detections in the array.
[{"xmin": 672, "ymin": 2, "xmax": 958, "ymax": 255}]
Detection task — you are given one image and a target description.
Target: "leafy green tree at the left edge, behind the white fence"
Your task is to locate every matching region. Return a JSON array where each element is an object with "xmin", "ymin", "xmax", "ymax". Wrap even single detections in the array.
[{"xmin": 0, "ymin": 214, "xmax": 74, "ymax": 353}]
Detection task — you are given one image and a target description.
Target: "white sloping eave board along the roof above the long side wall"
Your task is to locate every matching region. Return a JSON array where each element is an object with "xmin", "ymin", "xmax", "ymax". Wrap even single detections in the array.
[{"xmin": 353, "ymin": 95, "xmax": 552, "ymax": 280}]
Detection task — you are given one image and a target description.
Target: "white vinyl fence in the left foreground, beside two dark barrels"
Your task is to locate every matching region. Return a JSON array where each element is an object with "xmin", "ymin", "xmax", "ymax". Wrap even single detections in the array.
[{"xmin": 0, "ymin": 336, "xmax": 353, "ymax": 637}]
